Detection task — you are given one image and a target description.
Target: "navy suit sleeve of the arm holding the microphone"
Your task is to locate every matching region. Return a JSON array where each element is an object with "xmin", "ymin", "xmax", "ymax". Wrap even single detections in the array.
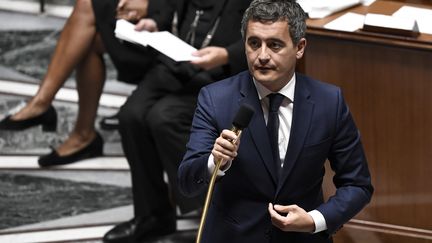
[{"xmin": 178, "ymin": 88, "xmax": 219, "ymax": 197}]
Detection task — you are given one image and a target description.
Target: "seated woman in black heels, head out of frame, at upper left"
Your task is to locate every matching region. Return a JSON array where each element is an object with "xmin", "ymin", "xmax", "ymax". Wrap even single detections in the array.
[{"xmin": 0, "ymin": 0, "xmax": 155, "ymax": 166}]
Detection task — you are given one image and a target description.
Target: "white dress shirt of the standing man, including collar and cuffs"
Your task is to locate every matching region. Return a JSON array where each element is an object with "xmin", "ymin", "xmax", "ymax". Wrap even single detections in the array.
[{"xmin": 208, "ymin": 74, "xmax": 327, "ymax": 233}]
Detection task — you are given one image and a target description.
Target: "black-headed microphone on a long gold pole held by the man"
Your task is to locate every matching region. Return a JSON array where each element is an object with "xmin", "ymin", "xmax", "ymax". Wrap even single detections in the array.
[{"xmin": 195, "ymin": 103, "xmax": 255, "ymax": 243}]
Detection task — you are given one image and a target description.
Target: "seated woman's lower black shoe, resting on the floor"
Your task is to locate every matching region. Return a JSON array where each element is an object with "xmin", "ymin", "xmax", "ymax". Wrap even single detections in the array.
[{"xmin": 38, "ymin": 132, "xmax": 104, "ymax": 167}]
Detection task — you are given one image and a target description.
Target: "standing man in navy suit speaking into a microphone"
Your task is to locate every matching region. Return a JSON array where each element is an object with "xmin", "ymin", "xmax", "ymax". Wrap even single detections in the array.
[{"xmin": 178, "ymin": 0, "xmax": 373, "ymax": 243}]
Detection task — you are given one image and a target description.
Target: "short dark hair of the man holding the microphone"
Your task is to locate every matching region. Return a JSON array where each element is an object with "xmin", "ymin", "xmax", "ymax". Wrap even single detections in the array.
[{"xmin": 241, "ymin": 0, "xmax": 307, "ymax": 45}]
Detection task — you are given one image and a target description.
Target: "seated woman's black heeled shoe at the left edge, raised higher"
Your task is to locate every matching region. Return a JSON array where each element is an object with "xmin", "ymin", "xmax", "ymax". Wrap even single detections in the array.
[{"xmin": 0, "ymin": 106, "xmax": 57, "ymax": 132}]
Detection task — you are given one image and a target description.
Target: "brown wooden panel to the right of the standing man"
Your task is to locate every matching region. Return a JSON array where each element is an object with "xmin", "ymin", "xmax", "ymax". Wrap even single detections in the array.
[{"xmin": 300, "ymin": 28, "xmax": 432, "ymax": 242}]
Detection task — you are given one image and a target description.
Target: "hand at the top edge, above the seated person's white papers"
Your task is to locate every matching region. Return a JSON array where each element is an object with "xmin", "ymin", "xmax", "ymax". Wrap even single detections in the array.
[{"xmin": 117, "ymin": 0, "xmax": 148, "ymax": 22}]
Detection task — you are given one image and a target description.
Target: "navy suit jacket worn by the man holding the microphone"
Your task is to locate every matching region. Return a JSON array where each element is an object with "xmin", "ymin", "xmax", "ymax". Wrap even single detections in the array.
[{"xmin": 179, "ymin": 71, "xmax": 373, "ymax": 243}]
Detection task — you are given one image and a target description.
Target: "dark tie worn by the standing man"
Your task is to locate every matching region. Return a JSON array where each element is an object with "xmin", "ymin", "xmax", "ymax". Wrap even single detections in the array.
[{"xmin": 267, "ymin": 93, "xmax": 285, "ymax": 171}]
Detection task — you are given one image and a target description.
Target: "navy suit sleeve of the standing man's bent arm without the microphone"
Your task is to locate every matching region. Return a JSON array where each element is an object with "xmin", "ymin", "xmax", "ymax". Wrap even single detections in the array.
[{"xmin": 317, "ymin": 90, "xmax": 373, "ymax": 234}]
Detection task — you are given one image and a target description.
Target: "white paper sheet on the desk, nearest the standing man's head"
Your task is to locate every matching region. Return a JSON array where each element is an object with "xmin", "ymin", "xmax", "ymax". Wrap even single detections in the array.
[{"xmin": 324, "ymin": 12, "xmax": 365, "ymax": 32}]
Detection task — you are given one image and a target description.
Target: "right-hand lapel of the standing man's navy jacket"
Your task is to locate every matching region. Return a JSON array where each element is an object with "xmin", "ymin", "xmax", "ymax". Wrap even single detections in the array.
[{"xmin": 277, "ymin": 75, "xmax": 314, "ymax": 193}]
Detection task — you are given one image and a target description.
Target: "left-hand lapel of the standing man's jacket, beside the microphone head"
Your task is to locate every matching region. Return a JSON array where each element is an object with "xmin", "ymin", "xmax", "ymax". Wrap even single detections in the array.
[{"xmin": 239, "ymin": 75, "xmax": 278, "ymax": 185}]
